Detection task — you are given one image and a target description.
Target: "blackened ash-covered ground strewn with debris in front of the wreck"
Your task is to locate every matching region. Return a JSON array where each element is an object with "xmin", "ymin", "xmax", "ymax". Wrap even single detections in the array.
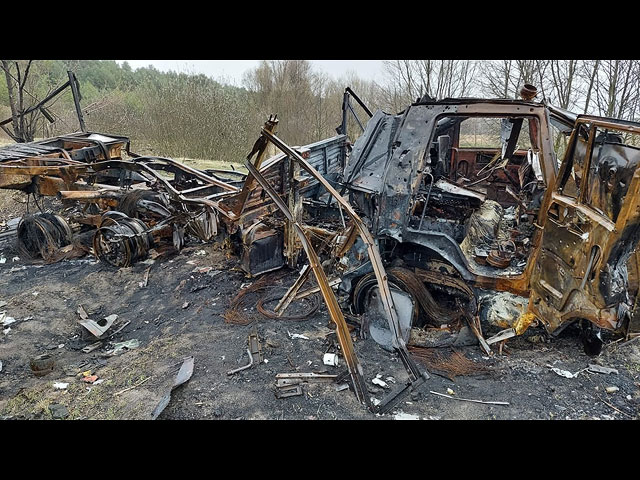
[{"xmin": 0, "ymin": 221, "xmax": 640, "ymax": 420}]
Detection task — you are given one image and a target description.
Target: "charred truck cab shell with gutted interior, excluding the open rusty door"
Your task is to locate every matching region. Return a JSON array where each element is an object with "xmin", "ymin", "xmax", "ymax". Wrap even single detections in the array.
[{"xmin": 344, "ymin": 99, "xmax": 558, "ymax": 295}]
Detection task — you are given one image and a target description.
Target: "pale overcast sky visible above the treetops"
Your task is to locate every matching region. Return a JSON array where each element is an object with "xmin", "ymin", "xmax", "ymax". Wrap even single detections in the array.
[{"xmin": 117, "ymin": 60, "xmax": 383, "ymax": 86}]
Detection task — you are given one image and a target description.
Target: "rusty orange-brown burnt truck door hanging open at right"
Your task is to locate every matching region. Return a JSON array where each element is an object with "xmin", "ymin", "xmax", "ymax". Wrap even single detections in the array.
[{"xmin": 529, "ymin": 116, "xmax": 640, "ymax": 353}]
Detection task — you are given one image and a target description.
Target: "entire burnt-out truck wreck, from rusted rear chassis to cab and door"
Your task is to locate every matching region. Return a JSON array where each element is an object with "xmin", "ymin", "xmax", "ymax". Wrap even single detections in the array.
[{"xmin": 0, "ymin": 86, "xmax": 640, "ymax": 411}]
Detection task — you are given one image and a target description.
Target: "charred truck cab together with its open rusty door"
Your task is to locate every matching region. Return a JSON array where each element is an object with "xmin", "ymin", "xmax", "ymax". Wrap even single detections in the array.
[{"xmin": 341, "ymin": 93, "xmax": 638, "ymax": 344}]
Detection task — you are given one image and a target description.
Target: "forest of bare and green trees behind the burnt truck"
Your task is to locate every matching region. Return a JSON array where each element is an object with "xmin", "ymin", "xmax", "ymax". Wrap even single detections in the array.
[{"xmin": 0, "ymin": 60, "xmax": 640, "ymax": 162}]
